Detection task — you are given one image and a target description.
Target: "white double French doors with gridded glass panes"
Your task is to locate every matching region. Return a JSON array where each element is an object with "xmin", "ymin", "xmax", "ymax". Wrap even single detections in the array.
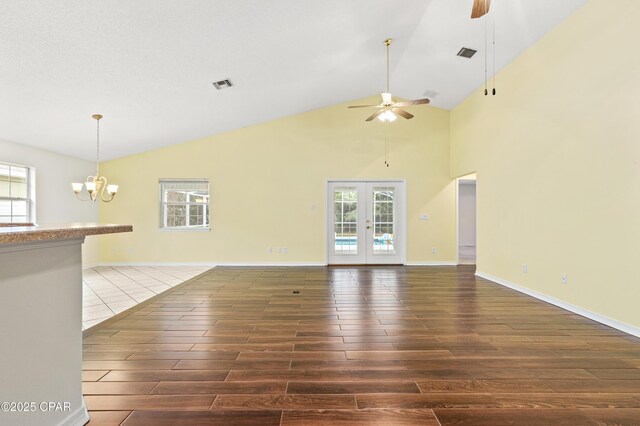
[{"xmin": 326, "ymin": 181, "xmax": 405, "ymax": 265}]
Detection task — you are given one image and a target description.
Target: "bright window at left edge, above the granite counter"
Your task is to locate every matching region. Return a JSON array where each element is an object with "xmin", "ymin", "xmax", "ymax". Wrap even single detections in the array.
[{"xmin": 0, "ymin": 163, "xmax": 35, "ymax": 223}]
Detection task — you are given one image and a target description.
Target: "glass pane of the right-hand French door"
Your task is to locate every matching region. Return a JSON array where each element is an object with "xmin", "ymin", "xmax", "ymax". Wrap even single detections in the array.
[{"xmin": 373, "ymin": 187, "xmax": 396, "ymax": 254}]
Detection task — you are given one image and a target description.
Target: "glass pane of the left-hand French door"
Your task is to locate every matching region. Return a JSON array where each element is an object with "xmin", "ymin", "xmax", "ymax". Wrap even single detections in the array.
[{"xmin": 333, "ymin": 188, "xmax": 358, "ymax": 254}]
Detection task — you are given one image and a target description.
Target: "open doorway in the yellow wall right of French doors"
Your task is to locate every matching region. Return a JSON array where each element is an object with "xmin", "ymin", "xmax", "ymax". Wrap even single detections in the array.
[{"xmin": 458, "ymin": 173, "xmax": 477, "ymax": 265}]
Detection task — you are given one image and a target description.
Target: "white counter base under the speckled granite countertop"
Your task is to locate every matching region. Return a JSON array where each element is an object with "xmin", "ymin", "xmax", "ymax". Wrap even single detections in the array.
[{"xmin": 0, "ymin": 237, "xmax": 89, "ymax": 426}]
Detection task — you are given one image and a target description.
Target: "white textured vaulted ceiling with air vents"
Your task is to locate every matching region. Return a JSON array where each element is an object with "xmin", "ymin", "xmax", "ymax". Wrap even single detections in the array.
[{"xmin": 0, "ymin": 0, "xmax": 586, "ymax": 159}]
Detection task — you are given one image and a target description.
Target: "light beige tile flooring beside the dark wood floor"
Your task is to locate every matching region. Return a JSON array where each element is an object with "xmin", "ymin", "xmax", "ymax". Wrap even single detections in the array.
[{"xmin": 82, "ymin": 266, "xmax": 210, "ymax": 330}]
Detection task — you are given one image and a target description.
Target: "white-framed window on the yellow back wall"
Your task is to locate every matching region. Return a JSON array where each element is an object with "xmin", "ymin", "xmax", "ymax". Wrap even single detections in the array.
[{"xmin": 160, "ymin": 179, "xmax": 210, "ymax": 230}]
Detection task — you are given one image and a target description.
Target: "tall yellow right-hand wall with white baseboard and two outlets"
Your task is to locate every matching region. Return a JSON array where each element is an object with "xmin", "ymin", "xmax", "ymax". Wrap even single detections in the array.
[{"xmin": 451, "ymin": 0, "xmax": 640, "ymax": 327}]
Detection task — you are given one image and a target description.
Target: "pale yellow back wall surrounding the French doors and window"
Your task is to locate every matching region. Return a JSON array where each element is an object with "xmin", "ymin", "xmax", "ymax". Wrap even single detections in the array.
[{"xmin": 100, "ymin": 97, "xmax": 455, "ymax": 264}]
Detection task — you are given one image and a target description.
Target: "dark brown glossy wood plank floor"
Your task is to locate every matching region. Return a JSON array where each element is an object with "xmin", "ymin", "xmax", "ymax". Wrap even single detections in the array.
[{"xmin": 83, "ymin": 266, "xmax": 640, "ymax": 426}]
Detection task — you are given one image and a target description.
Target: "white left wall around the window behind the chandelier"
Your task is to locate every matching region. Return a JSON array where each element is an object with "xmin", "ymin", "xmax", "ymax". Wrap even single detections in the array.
[{"xmin": 0, "ymin": 140, "xmax": 99, "ymax": 268}]
